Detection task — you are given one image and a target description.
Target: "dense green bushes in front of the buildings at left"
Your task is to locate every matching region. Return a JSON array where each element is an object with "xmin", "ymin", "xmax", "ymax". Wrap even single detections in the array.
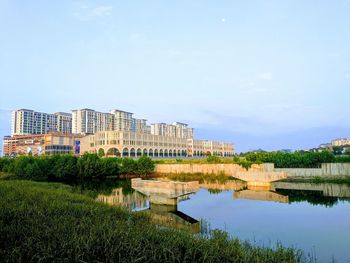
[{"xmin": 0, "ymin": 154, "xmax": 154, "ymax": 184}]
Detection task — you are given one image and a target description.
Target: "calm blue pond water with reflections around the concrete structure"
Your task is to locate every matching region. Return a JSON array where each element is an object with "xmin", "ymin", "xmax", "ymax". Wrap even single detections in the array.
[{"xmin": 92, "ymin": 178, "xmax": 350, "ymax": 262}]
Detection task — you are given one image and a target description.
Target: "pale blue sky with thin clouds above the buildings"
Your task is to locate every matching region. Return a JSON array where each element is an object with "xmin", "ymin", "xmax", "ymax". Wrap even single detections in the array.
[{"xmin": 0, "ymin": 0, "xmax": 350, "ymax": 152}]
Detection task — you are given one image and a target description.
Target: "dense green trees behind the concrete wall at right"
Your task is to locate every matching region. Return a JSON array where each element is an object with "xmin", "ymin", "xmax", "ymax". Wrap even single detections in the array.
[{"xmin": 245, "ymin": 151, "xmax": 337, "ymax": 168}]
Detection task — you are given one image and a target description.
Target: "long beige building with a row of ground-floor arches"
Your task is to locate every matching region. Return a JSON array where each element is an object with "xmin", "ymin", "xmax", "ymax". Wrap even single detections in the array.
[{"xmin": 81, "ymin": 131, "xmax": 234, "ymax": 158}]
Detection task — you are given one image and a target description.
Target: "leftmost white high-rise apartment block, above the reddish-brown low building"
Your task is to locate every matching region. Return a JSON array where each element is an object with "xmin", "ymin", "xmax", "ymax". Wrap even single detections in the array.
[{"xmin": 11, "ymin": 109, "xmax": 72, "ymax": 135}]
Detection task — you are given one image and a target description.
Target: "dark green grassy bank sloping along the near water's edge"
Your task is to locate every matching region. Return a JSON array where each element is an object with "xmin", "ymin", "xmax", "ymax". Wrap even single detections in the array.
[{"xmin": 0, "ymin": 180, "xmax": 304, "ymax": 262}]
